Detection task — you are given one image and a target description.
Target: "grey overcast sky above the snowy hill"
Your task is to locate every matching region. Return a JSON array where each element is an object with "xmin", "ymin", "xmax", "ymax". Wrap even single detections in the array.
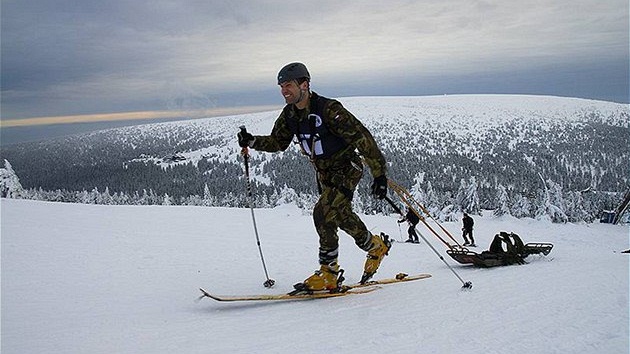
[{"xmin": 1, "ymin": 0, "xmax": 629, "ymax": 120}]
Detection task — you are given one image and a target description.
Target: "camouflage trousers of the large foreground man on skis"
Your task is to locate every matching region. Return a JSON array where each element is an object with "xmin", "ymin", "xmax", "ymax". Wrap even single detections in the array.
[{"xmin": 313, "ymin": 165, "xmax": 371, "ymax": 264}]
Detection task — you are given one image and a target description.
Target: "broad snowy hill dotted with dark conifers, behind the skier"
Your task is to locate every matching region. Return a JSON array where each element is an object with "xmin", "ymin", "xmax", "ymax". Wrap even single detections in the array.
[{"xmin": 0, "ymin": 95, "xmax": 630, "ymax": 221}]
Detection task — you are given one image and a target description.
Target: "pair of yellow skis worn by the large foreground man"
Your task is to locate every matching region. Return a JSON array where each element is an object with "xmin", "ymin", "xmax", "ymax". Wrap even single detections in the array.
[{"xmin": 199, "ymin": 273, "xmax": 431, "ymax": 302}]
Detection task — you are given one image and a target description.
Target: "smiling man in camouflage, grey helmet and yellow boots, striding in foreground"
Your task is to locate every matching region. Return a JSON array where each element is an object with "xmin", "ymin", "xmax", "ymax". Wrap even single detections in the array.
[{"xmin": 238, "ymin": 63, "xmax": 391, "ymax": 291}]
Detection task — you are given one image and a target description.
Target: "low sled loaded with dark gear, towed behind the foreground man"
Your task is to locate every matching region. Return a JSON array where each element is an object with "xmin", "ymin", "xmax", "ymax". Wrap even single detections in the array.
[{"xmin": 446, "ymin": 231, "xmax": 553, "ymax": 267}]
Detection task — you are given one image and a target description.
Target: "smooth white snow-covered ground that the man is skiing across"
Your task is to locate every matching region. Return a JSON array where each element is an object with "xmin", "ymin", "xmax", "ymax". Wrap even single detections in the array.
[{"xmin": 1, "ymin": 199, "xmax": 630, "ymax": 354}]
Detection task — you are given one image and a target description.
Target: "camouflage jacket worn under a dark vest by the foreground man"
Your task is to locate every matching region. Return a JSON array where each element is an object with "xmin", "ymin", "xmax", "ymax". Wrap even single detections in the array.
[{"xmin": 252, "ymin": 92, "xmax": 387, "ymax": 178}]
